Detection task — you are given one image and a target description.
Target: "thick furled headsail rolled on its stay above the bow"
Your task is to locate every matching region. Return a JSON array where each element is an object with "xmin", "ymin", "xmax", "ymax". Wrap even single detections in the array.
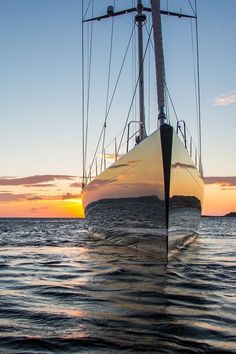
[{"xmin": 151, "ymin": 0, "xmax": 166, "ymax": 125}]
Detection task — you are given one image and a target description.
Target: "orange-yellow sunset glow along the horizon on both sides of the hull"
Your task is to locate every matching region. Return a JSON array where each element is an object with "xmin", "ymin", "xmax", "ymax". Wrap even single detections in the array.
[{"xmin": 0, "ymin": 183, "xmax": 236, "ymax": 218}]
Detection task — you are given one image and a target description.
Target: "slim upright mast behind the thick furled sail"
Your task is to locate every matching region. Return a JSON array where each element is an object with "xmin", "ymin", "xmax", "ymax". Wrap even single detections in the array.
[{"xmin": 135, "ymin": 0, "xmax": 146, "ymax": 141}]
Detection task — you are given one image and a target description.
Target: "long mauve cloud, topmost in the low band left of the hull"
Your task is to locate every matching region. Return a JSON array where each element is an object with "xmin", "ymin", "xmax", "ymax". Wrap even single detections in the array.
[{"xmin": 0, "ymin": 175, "xmax": 75, "ymax": 187}]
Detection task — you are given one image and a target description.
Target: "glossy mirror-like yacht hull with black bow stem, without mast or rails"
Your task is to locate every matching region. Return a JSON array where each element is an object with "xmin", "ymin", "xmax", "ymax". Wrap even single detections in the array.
[{"xmin": 82, "ymin": 124, "xmax": 203, "ymax": 258}]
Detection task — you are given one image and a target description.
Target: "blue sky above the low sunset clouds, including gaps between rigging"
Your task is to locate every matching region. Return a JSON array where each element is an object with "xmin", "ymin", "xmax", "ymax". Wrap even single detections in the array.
[{"xmin": 0, "ymin": 0, "xmax": 236, "ymax": 214}]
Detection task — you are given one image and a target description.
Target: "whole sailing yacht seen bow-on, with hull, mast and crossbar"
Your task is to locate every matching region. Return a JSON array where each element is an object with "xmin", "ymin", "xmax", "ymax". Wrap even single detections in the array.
[{"xmin": 82, "ymin": 0, "xmax": 204, "ymax": 259}]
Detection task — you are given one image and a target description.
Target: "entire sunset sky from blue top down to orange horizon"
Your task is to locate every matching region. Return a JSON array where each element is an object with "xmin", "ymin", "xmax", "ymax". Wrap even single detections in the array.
[{"xmin": 0, "ymin": 0, "xmax": 236, "ymax": 217}]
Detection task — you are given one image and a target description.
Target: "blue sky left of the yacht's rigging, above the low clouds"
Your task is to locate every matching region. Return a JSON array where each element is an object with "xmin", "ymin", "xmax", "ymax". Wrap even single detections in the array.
[{"xmin": 0, "ymin": 0, "xmax": 81, "ymax": 176}]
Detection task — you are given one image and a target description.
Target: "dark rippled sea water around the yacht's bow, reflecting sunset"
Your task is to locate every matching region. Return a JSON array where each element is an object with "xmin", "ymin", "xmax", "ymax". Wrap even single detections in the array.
[{"xmin": 0, "ymin": 218, "xmax": 236, "ymax": 354}]
